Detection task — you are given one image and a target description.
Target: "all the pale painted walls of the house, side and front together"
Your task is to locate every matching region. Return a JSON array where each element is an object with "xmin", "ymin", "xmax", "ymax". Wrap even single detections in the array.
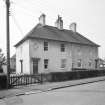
[{"xmin": 16, "ymin": 39, "xmax": 98, "ymax": 74}]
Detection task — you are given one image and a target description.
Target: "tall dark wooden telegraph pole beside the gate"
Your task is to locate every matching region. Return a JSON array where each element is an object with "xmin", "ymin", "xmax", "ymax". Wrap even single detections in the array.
[{"xmin": 6, "ymin": 0, "xmax": 10, "ymax": 88}]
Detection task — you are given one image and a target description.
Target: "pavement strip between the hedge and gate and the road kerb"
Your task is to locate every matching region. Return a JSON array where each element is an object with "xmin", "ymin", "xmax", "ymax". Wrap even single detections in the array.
[{"xmin": 0, "ymin": 76, "xmax": 105, "ymax": 99}]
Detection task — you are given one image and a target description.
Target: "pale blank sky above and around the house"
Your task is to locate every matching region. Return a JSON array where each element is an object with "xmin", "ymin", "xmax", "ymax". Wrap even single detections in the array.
[{"xmin": 0, "ymin": 0, "xmax": 105, "ymax": 58}]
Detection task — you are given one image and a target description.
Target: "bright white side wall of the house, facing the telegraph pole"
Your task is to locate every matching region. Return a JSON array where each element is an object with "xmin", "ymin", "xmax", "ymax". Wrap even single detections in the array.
[{"xmin": 16, "ymin": 40, "xmax": 30, "ymax": 74}]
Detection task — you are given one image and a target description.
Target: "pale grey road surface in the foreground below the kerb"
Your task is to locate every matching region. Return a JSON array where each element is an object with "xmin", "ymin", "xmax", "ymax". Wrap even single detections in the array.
[{"xmin": 0, "ymin": 81, "xmax": 105, "ymax": 105}]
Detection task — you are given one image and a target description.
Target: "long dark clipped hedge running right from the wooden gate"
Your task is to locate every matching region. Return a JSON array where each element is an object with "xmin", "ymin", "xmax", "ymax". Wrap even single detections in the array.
[{"xmin": 43, "ymin": 70, "xmax": 105, "ymax": 82}]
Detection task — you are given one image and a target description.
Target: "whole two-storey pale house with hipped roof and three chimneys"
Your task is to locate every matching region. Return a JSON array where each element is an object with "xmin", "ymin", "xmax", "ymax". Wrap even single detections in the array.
[{"xmin": 15, "ymin": 14, "xmax": 99, "ymax": 74}]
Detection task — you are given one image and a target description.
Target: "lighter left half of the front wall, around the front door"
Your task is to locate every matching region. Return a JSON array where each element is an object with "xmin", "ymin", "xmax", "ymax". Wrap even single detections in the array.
[{"xmin": 30, "ymin": 39, "xmax": 72, "ymax": 73}]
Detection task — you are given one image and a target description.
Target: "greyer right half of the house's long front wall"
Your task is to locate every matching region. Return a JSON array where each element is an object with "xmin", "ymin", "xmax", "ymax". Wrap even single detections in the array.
[{"xmin": 72, "ymin": 44, "xmax": 98, "ymax": 69}]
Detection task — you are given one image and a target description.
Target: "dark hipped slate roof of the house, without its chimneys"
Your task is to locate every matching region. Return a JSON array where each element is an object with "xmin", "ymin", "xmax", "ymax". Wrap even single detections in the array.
[{"xmin": 15, "ymin": 24, "xmax": 99, "ymax": 47}]
